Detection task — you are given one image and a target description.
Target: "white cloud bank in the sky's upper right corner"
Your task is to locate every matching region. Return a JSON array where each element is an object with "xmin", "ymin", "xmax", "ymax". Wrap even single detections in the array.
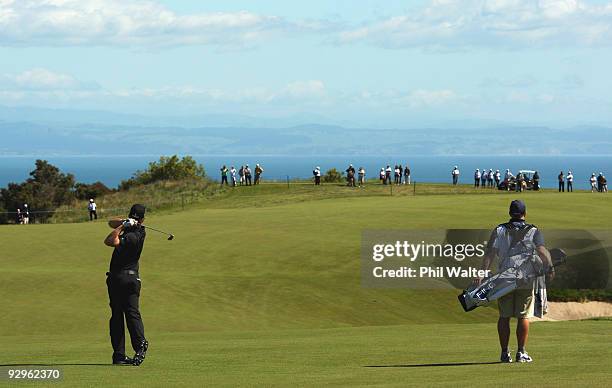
[{"xmin": 338, "ymin": 0, "xmax": 612, "ymax": 48}]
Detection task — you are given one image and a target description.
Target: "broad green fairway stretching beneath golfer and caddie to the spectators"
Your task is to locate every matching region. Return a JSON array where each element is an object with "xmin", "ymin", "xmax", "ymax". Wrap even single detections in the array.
[{"xmin": 0, "ymin": 185, "xmax": 612, "ymax": 386}]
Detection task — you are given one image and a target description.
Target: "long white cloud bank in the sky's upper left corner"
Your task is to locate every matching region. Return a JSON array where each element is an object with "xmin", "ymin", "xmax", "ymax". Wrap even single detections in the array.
[{"xmin": 0, "ymin": 0, "xmax": 288, "ymax": 46}]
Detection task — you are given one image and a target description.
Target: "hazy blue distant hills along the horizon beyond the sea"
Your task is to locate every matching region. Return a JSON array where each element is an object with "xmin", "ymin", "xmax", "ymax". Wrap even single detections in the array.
[{"xmin": 0, "ymin": 121, "xmax": 612, "ymax": 155}]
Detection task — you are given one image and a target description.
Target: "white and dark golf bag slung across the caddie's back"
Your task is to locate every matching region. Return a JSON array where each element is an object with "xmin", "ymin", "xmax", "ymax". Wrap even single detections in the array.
[{"xmin": 457, "ymin": 223, "xmax": 567, "ymax": 312}]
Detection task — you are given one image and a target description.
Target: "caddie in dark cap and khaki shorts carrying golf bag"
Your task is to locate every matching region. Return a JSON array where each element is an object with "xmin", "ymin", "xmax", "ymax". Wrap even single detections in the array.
[{"xmin": 474, "ymin": 200, "xmax": 554, "ymax": 362}]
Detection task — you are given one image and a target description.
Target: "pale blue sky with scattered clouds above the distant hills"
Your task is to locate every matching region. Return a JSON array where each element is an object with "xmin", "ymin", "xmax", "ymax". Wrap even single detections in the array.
[{"xmin": 0, "ymin": 0, "xmax": 612, "ymax": 127}]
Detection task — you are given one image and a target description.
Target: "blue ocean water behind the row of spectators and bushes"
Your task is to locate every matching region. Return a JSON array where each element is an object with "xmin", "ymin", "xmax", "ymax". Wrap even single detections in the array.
[{"xmin": 0, "ymin": 155, "xmax": 612, "ymax": 189}]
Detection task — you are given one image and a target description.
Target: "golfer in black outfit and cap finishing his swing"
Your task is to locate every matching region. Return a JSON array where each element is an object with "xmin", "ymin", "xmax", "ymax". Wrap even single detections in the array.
[{"xmin": 104, "ymin": 204, "xmax": 149, "ymax": 366}]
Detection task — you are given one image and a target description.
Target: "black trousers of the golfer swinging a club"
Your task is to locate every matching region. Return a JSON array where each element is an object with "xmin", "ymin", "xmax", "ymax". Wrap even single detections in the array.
[{"xmin": 106, "ymin": 274, "xmax": 145, "ymax": 356}]
